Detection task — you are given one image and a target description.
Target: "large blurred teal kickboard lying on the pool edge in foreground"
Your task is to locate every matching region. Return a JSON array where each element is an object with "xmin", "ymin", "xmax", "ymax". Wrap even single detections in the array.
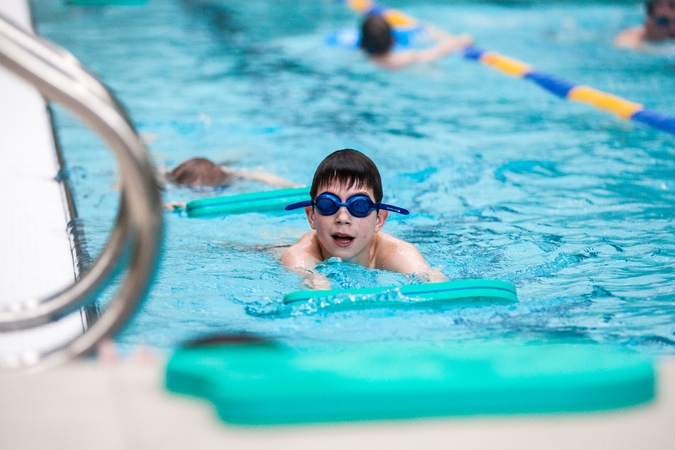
[{"xmin": 166, "ymin": 341, "xmax": 655, "ymax": 425}]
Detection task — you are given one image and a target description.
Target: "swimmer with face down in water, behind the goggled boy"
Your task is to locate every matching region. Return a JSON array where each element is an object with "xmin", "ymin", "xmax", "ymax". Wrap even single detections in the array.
[{"xmin": 160, "ymin": 158, "xmax": 301, "ymax": 209}]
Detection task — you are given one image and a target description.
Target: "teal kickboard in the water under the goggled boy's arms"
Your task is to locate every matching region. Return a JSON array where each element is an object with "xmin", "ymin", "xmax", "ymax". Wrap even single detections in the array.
[{"xmin": 283, "ymin": 279, "xmax": 518, "ymax": 309}]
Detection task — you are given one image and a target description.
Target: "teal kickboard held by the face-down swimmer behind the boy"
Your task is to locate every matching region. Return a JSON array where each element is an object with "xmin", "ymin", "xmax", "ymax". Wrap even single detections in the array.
[{"xmin": 185, "ymin": 186, "xmax": 310, "ymax": 217}]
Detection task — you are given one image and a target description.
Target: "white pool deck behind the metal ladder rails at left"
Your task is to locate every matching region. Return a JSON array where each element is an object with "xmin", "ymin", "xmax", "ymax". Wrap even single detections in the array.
[{"xmin": 0, "ymin": 0, "xmax": 86, "ymax": 356}]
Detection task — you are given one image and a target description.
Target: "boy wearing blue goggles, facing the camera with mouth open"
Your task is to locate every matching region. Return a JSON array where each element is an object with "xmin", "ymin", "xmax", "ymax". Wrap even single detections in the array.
[{"xmin": 281, "ymin": 149, "xmax": 446, "ymax": 289}]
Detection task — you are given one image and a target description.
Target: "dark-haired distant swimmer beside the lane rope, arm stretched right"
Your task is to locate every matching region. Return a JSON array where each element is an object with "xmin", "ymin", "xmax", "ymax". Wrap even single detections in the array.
[{"xmin": 360, "ymin": 14, "xmax": 473, "ymax": 69}]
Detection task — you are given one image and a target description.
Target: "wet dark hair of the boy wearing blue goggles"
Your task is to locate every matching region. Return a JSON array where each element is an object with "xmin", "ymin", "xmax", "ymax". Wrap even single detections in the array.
[{"xmin": 309, "ymin": 148, "xmax": 382, "ymax": 203}]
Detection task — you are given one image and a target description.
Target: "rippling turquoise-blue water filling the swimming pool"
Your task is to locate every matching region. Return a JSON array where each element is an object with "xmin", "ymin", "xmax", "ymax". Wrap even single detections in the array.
[{"xmin": 33, "ymin": 0, "xmax": 675, "ymax": 354}]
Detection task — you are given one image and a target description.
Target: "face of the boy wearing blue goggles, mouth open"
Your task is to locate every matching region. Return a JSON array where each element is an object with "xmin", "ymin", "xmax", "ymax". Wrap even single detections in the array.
[{"xmin": 305, "ymin": 179, "xmax": 388, "ymax": 267}]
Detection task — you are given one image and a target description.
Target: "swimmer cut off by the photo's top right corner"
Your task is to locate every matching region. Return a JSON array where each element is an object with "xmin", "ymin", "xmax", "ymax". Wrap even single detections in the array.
[{"xmin": 614, "ymin": 0, "xmax": 675, "ymax": 50}]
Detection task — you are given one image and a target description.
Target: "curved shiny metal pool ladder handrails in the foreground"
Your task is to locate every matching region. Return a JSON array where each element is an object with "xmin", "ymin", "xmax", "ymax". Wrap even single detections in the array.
[{"xmin": 0, "ymin": 15, "xmax": 162, "ymax": 371}]
